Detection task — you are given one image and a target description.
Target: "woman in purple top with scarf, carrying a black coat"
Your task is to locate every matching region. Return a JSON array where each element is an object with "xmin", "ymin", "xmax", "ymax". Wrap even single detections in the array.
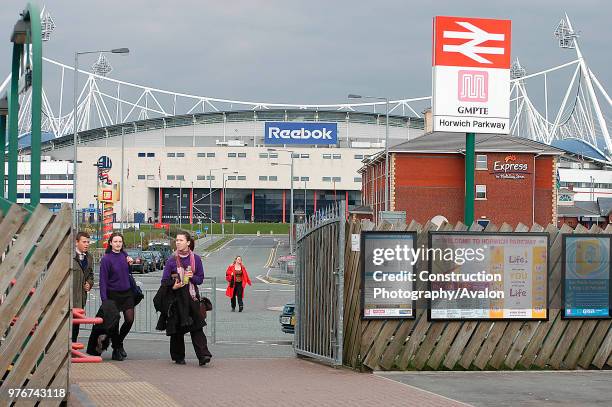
[{"xmin": 158, "ymin": 232, "xmax": 212, "ymax": 366}]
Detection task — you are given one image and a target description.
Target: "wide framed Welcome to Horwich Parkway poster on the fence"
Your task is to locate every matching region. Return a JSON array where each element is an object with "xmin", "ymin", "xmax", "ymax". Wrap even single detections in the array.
[{"xmin": 428, "ymin": 232, "xmax": 548, "ymax": 320}]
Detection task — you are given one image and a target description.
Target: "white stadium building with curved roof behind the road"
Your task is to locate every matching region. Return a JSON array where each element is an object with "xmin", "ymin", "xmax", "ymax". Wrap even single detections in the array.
[{"xmin": 32, "ymin": 109, "xmax": 424, "ymax": 223}]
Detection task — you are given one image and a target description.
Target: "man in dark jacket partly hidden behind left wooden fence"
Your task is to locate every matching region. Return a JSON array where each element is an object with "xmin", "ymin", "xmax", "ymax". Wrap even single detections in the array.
[{"xmin": 72, "ymin": 232, "xmax": 94, "ymax": 342}]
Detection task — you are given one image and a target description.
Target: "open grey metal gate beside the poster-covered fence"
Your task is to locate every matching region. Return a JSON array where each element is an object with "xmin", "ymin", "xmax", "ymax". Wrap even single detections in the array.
[{"xmin": 293, "ymin": 201, "xmax": 346, "ymax": 366}]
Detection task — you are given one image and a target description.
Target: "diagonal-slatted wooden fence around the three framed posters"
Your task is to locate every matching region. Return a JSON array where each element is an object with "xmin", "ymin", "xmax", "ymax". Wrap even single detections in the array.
[{"xmin": 344, "ymin": 222, "xmax": 612, "ymax": 370}]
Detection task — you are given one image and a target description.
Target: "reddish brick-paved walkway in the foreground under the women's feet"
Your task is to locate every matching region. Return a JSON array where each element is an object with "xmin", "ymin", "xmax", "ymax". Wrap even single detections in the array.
[{"xmin": 70, "ymin": 358, "xmax": 466, "ymax": 407}]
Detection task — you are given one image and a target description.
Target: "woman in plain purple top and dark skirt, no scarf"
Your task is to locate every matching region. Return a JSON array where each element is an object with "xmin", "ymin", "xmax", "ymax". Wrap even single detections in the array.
[{"xmin": 100, "ymin": 233, "xmax": 134, "ymax": 361}]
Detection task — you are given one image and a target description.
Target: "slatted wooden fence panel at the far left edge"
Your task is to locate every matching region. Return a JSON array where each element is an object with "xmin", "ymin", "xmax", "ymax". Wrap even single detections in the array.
[{"xmin": 0, "ymin": 204, "xmax": 71, "ymax": 405}]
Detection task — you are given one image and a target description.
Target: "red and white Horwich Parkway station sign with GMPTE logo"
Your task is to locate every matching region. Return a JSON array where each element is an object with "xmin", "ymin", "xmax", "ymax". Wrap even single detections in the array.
[{"xmin": 432, "ymin": 16, "xmax": 511, "ymax": 134}]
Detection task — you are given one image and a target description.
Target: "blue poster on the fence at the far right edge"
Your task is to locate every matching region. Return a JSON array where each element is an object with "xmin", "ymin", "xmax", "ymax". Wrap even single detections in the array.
[{"xmin": 562, "ymin": 235, "xmax": 612, "ymax": 319}]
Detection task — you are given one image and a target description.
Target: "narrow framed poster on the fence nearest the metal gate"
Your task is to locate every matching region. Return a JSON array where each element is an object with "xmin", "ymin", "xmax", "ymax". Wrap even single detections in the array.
[{"xmin": 361, "ymin": 231, "xmax": 416, "ymax": 319}]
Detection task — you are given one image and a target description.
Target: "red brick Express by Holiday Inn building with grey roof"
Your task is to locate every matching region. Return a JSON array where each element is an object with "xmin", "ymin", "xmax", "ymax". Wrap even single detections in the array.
[{"xmin": 360, "ymin": 132, "xmax": 563, "ymax": 225}]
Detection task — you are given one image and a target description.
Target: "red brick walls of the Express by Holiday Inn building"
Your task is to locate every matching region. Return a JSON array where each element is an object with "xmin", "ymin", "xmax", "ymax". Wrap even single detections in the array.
[{"xmin": 388, "ymin": 153, "xmax": 554, "ymax": 226}]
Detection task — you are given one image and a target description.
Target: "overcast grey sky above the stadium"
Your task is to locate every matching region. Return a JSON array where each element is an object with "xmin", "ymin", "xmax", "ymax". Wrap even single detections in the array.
[{"xmin": 0, "ymin": 0, "xmax": 612, "ymax": 108}]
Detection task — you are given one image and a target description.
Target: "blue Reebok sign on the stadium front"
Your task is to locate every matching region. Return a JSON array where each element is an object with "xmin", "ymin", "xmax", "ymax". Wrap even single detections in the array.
[{"xmin": 264, "ymin": 122, "xmax": 338, "ymax": 145}]
